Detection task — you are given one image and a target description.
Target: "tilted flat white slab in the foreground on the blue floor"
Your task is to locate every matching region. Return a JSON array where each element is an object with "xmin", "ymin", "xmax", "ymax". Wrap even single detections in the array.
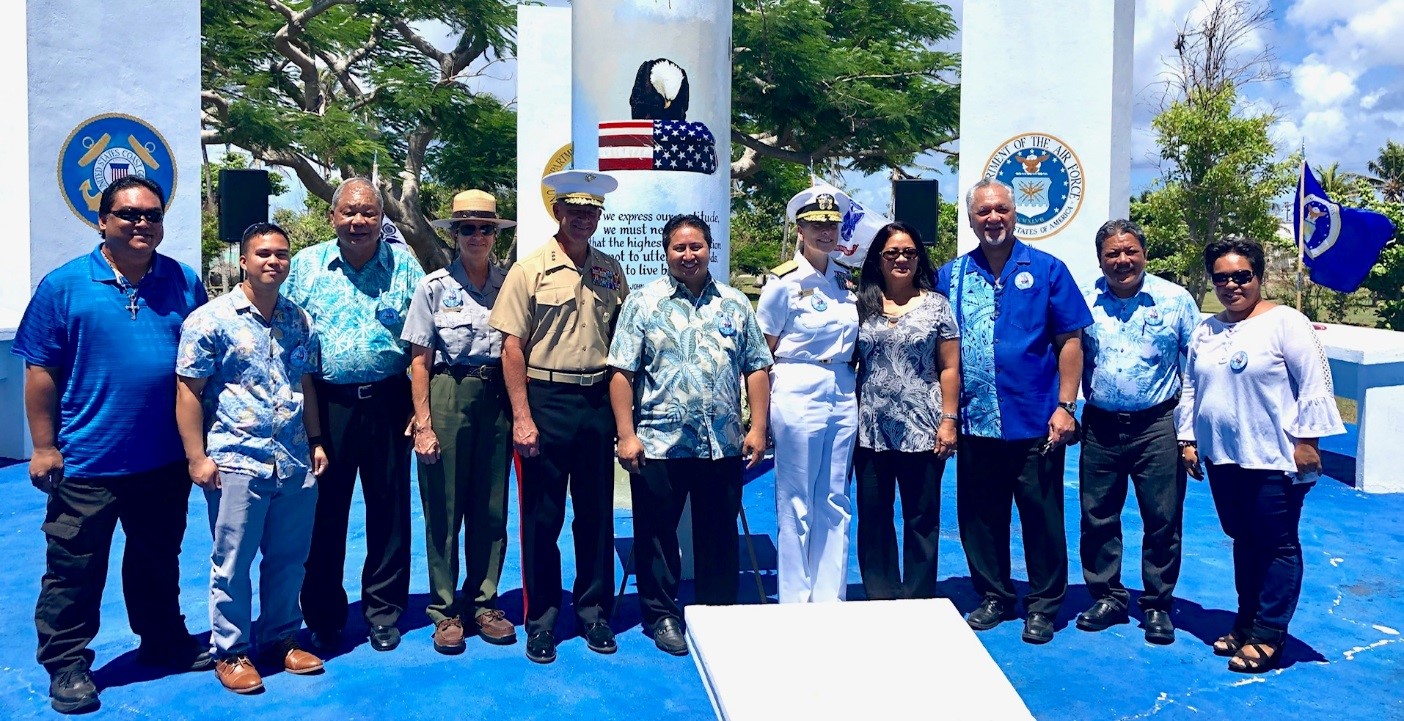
[{"xmin": 685, "ymin": 599, "xmax": 1033, "ymax": 721}]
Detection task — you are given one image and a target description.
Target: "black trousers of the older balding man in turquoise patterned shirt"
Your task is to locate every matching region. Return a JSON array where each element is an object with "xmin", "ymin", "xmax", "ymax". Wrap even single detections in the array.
[{"xmin": 302, "ymin": 377, "xmax": 411, "ymax": 631}]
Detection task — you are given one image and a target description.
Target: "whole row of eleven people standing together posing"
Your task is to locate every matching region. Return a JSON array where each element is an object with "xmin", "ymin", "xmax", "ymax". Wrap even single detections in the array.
[{"xmin": 13, "ymin": 171, "xmax": 1342, "ymax": 713}]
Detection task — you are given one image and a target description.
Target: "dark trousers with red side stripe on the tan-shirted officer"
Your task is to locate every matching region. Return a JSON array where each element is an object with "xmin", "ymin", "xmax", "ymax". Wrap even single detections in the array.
[{"xmin": 517, "ymin": 380, "xmax": 615, "ymax": 634}]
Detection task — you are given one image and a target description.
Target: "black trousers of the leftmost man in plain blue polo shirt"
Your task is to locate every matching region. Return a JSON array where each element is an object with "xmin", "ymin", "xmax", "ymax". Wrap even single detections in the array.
[{"xmin": 34, "ymin": 460, "xmax": 191, "ymax": 673}]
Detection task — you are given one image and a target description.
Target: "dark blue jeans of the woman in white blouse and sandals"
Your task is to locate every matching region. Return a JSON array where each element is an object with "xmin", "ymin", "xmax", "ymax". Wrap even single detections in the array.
[{"xmin": 1209, "ymin": 464, "xmax": 1313, "ymax": 644}]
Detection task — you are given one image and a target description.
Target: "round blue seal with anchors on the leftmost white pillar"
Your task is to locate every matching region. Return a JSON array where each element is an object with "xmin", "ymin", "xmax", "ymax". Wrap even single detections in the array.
[{"xmin": 59, "ymin": 112, "xmax": 176, "ymax": 227}]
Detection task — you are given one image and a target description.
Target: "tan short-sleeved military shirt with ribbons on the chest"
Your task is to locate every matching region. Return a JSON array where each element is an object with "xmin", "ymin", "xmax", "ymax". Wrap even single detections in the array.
[{"xmin": 489, "ymin": 238, "xmax": 629, "ymax": 373}]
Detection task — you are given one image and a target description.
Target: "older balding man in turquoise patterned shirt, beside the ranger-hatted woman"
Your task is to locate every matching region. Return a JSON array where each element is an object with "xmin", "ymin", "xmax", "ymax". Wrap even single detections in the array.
[{"xmin": 284, "ymin": 178, "xmax": 424, "ymax": 651}]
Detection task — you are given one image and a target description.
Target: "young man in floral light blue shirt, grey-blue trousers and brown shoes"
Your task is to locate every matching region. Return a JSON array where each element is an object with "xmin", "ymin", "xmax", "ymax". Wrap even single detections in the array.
[{"xmin": 176, "ymin": 223, "xmax": 327, "ymax": 693}]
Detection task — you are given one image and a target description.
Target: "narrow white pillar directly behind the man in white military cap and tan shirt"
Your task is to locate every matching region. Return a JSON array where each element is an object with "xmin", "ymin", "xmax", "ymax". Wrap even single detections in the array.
[{"xmin": 514, "ymin": 6, "xmax": 571, "ymax": 258}]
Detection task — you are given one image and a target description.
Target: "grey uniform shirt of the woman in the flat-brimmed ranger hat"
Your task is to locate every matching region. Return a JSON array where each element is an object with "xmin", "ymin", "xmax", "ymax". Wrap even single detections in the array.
[{"xmin": 400, "ymin": 258, "xmax": 507, "ymax": 366}]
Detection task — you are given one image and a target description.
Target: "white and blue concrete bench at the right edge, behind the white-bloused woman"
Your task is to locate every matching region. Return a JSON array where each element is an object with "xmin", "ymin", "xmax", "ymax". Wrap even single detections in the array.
[{"xmin": 1317, "ymin": 324, "xmax": 1404, "ymax": 494}]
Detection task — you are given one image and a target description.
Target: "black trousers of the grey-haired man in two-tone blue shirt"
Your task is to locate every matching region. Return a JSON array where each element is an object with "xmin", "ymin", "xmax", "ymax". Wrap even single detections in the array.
[{"xmin": 956, "ymin": 436, "xmax": 1067, "ymax": 617}]
